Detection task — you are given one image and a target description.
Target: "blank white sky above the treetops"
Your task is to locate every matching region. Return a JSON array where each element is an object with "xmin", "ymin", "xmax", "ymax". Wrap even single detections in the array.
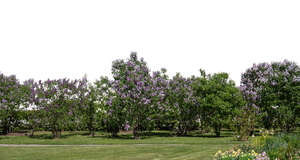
[{"xmin": 0, "ymin": 0, "xmax": 300, "ymax": 85}]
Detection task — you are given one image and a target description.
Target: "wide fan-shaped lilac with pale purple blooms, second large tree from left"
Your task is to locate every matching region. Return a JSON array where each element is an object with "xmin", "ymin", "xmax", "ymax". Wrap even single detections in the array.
[{"xmin": 30, "ymin": 78, "xmax": 86, "ymax": 138}]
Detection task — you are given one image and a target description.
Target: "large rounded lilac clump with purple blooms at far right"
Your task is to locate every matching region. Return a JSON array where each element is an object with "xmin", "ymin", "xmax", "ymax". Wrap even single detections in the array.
[{"xmin": 240, "ymin": 60, "xmax": 300, "ymax": 131}]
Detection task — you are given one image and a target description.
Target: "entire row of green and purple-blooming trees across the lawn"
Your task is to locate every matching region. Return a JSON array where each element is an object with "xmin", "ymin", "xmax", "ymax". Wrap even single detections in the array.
[{"xmin": 0, "ymin": 53, "xmax": 300, "ymax": 139}]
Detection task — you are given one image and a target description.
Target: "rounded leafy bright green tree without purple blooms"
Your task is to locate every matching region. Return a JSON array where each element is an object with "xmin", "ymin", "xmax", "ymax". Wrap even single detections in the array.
[{"xmin": 193, "ymin": 70, "xmax": 243, "ymax": 136}]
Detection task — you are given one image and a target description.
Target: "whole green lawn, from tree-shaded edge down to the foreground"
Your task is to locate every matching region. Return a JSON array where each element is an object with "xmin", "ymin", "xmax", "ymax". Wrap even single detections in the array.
[{"xmin": 0, "ymin": 132, "xmax": 246, "ymax": 160}]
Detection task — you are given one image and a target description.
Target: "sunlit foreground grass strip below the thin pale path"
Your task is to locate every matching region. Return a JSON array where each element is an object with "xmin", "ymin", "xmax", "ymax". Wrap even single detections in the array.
[{"xmin": 0, "ymin": 144, "xmax": 236, "ymax": 160}]
